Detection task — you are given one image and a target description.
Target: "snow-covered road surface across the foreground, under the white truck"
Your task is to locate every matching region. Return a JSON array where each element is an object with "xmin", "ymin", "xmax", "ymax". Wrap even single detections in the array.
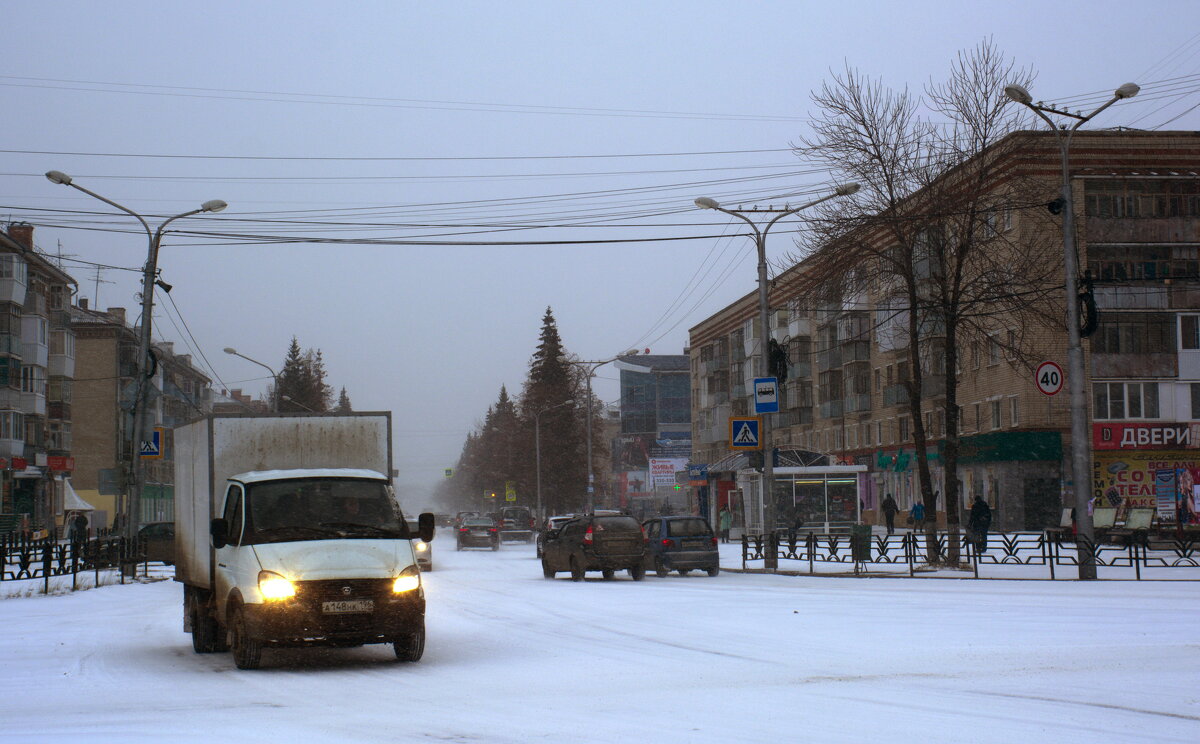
[{"xmin": 0, "ymin": 539, "xmax": 1200, "ymax": 744}]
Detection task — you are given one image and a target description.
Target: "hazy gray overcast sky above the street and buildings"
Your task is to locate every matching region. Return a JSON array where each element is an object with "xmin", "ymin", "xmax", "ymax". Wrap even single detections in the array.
[{"xmin": 0, "ymin": 0, "xmax": 1200, "ymax": 499}]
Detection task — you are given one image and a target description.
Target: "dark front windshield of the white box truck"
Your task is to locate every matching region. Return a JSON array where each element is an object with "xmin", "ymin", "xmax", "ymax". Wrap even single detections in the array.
[{"xmin": 244, "ymin": 478, "xmax": 409, "ymax": 544}]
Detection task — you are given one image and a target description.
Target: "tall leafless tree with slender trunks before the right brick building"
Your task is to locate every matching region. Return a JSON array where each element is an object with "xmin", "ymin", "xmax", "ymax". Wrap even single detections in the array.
[{"xmin": 797, "ymin": 40, "xmax": 1055, "ymax": 563}]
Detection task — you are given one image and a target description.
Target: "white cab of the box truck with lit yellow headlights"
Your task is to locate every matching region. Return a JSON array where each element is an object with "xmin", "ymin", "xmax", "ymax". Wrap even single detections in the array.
[{"xmin": 193, "ymin": 468, "xmax": 433, "ymax": 668}]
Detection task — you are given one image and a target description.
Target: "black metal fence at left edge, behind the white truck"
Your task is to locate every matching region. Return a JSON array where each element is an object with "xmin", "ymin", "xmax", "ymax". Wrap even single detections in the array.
[{"xmin": 0, "ymin": 534, "xmax": 157, "ymax": 593}]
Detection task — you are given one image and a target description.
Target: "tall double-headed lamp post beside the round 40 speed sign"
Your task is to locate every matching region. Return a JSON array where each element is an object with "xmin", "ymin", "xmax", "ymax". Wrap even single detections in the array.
[{"xmin": 1004, "ymin": 83, "xmax": 1140, "ymax": 580}]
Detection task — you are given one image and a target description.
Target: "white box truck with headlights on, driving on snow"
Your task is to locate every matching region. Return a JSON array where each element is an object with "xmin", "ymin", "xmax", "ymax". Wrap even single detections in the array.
[{"xmin": 174, "ymin": 413, "xmax": 434, "ymax": 668}]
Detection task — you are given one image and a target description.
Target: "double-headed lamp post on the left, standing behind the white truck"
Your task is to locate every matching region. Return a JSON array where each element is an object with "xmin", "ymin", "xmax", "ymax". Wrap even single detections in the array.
[{"xmin": 46, "ymin": 170, "xmax": 228, "ymax": 539}]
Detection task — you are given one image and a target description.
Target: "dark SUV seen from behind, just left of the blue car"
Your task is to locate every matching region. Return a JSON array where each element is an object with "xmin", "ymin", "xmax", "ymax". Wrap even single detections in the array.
[{"xmin": 541, "ymin": 515, "xmax": 646, "ymax": 581}]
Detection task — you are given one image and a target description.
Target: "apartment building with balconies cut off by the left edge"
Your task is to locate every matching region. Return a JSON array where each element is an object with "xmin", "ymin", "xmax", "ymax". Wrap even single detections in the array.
[{"xmin": 0, "ymin": 224, "xmax": 76, "ymax": 532}]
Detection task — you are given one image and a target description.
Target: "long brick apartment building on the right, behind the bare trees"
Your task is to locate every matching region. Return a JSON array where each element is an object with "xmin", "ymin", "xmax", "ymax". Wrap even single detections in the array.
[{"xmin": 689, "ymin": 132, "xmax": 1200, "ymax": 529}]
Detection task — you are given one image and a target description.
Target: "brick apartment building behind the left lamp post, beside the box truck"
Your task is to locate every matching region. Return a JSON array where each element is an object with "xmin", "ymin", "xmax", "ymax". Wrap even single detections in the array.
[{"xmin": 72, "ymin": 300, "xmax": 212, "ymax": 526}]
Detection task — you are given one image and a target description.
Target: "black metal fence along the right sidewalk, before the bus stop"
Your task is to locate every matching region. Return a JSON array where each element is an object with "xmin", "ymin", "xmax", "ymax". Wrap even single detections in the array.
[{"xmin": 742, "ymin": 532, "xmax": 1200, "ymax": 581}]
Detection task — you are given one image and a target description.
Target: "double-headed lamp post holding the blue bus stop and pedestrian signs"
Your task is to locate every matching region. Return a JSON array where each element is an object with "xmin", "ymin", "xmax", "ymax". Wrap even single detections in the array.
[{"xmin": 696, "ymin": 184, "xmax": 858, "ymax": 570}]
